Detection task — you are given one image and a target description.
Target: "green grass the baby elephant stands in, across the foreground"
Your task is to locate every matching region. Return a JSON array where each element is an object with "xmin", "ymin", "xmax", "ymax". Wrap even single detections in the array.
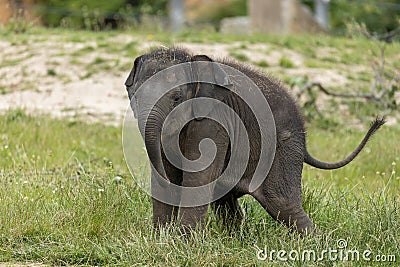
[{"xmin": 0, "ymin": 110, "xmax": 400, "ymax": 266}]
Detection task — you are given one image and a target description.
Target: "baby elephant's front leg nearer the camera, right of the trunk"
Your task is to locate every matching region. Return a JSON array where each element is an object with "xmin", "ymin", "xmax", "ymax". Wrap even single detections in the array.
[{"xmin": 180, "ymin": 119, "xmax": 229, "ymax": 232}]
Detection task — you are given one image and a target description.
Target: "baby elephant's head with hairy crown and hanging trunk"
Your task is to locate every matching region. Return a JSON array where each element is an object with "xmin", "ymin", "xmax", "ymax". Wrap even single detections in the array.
[{"xmin": 125, "ymin": 48, "xmax": 231, "ymax": 181}]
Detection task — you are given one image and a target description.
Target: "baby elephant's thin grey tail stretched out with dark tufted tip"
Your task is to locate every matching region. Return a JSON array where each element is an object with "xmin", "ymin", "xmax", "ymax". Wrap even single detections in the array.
[{"xmin": 304, "ymin": 118, "xmax": 386, "ymax": 170}]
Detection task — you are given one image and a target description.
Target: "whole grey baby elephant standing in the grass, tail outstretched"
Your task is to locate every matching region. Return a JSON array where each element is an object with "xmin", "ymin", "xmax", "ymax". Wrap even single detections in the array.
[{"xmin": 125, "ymin": 48, "xmax": 385, "ymax": 233}]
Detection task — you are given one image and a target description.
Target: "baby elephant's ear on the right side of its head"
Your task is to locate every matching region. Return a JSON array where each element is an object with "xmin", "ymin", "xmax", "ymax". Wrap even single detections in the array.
[{"xmin": 191, "ymin": 55, "xmax": 232, "ymax": 120}]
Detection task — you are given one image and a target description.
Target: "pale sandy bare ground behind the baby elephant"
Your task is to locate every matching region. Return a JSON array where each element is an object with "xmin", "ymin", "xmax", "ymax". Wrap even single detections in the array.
[{"xmin": 0, "ymin": 35, "xmax": 368, "ymax": 125}]
